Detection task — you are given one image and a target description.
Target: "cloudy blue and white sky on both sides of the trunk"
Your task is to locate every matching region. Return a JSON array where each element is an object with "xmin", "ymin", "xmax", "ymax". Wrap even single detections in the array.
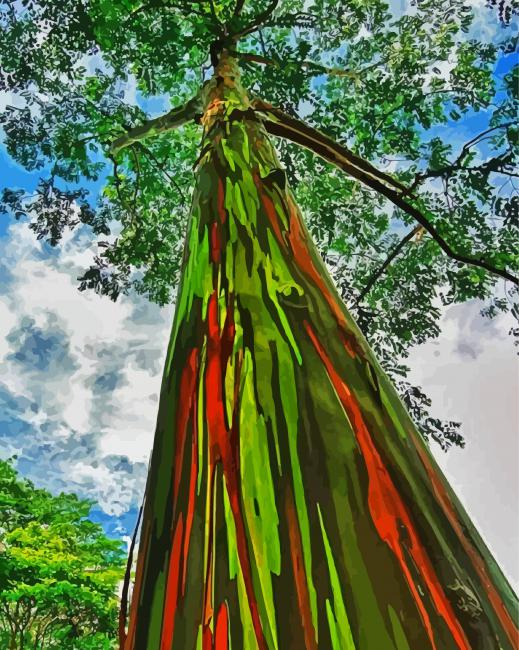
[{"xmin": 0, "ymin": 0, "xmax": 519, "ymax": 590}]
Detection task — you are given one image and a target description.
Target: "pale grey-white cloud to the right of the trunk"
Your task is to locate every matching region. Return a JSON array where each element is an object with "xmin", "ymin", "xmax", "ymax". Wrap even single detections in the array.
[{"xmin": 409, "ymin": 301, "xmax": 519, "ymax": 590}]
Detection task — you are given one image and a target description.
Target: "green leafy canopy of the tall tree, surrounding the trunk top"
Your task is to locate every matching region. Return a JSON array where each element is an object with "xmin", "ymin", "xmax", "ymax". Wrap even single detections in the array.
[{"xmin": 0, "ymin": 0, "xmax": 518, "ymax": 448}]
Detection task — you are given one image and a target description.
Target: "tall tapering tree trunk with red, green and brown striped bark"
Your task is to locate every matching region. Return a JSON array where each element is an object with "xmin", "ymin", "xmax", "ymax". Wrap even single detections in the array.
[{"xmin": 124, "ymin": 56, "xmax": 517, "ymax": 650}]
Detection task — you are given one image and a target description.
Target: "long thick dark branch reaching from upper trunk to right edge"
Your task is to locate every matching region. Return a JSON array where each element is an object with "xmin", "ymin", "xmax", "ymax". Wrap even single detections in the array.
[{"xmin": 255, "ymin": 102, "xmax": 519, "ymax": 284}]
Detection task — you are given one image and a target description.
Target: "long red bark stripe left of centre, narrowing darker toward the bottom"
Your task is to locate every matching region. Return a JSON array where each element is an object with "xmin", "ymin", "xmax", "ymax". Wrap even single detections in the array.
[{"xmin": 205, "ymin": 290, "xmax": 268, "ymax": 650}]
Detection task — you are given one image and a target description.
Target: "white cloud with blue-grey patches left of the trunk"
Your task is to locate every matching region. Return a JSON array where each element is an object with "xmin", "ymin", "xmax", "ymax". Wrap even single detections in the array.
[{"xmin": 0, "ymin": 223, "xmax": 172, "ymax": 515}]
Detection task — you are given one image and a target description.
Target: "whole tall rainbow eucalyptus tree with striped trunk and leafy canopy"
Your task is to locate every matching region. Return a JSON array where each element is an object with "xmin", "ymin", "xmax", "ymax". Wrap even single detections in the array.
[{"xmin": 0, "ymin": 0, "xmax": 518, "ymax": 650}]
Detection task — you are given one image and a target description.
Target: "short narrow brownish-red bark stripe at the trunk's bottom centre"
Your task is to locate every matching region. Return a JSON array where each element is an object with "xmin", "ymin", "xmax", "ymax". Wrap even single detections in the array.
[{"xmin": 285, "ymin": 488, "xmax": 317, "ymax": 650}]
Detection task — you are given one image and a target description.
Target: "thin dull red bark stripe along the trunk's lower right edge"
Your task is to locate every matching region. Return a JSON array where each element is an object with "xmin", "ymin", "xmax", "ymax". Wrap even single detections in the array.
[{"xmin": 415, "ymin": 442, "xmax": 519, "ymax": 647}]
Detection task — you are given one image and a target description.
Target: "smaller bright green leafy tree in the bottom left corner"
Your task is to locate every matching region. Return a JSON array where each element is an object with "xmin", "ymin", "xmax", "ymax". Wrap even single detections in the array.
[{"xmin": 0, "ymin": 461, "xmax": 125, "ymax": 650}]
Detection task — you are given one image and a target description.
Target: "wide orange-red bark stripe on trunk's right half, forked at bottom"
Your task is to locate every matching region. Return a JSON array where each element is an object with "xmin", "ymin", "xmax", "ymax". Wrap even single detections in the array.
[{"xmin": 304, "ymin": 321, "xmax": 470, "ymax": 650}]
